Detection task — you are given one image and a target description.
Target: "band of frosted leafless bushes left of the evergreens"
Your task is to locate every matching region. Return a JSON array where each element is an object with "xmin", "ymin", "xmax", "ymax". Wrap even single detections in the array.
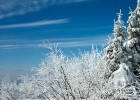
[{"xmin": 0, "ymin": 47, "xmax": 111, "ymax": 100}]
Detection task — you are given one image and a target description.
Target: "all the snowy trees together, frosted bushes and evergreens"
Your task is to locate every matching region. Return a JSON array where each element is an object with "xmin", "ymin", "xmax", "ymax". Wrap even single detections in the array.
[{"xmin": 0, "ymin": 0, "xmax": 140, "ymax": 100}]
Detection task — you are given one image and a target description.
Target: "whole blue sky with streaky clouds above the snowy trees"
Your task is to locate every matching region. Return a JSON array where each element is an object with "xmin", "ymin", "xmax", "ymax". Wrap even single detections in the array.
[{"xmin": 0, "ymin": 0, "xmax": 136, "ymax": 73}]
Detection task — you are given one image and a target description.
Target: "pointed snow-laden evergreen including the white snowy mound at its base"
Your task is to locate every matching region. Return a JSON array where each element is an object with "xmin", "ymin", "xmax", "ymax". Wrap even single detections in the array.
[{"xmin": 105, "ymin": 10, "xmax": 139, "ymax": 99}]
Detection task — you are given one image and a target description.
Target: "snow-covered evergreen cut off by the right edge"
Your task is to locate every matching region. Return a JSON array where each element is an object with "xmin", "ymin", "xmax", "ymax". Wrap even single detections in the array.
[{"xmin": 126, "ymin": 0, "xmax": 140, "ymax": 80}]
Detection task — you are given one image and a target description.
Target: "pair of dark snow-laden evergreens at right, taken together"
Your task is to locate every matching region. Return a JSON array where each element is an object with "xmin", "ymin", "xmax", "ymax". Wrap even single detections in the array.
[{"xmin": 105, "ymin": 0, "xmax": 140, "ymax": 96}]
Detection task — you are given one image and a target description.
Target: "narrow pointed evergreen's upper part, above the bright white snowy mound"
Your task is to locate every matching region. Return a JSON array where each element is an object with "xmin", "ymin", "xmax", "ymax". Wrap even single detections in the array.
[{"xmin": 106, "ymin": 10, "xmax": 126, "ymax": 72}]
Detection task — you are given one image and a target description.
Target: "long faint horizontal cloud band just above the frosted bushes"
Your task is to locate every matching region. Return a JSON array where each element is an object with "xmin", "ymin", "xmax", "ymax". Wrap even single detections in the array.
[{"xmin": 0, "ymin": 37, "xmax": 106, "ymax": 49}]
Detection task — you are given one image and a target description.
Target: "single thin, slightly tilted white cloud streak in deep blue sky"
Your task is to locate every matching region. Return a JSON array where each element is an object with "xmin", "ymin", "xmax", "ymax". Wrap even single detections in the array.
[{"xmin": 0, "ymin": 19, "xmax": 69, "ymax": 29}]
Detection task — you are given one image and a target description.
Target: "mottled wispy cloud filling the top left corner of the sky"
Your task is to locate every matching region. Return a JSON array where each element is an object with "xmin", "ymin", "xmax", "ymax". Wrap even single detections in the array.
[{"xmin": 0, "ymin": 0, "xmax": 86, "ymax": 19}]
